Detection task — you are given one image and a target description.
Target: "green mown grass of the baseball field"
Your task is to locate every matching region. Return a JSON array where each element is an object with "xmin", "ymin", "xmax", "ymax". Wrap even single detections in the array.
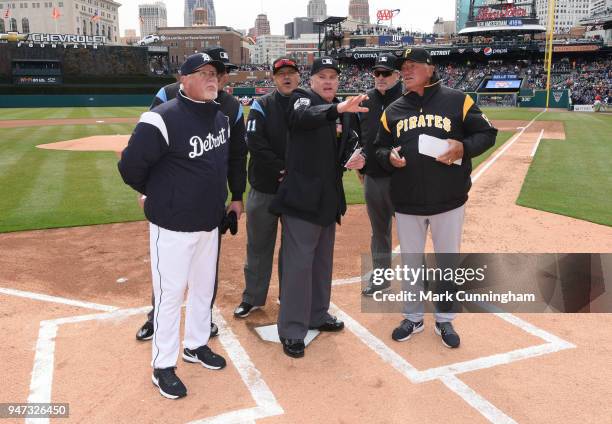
[{"xmin": 0, "ymin": 108, "xmax": 612, "ymax": 232}]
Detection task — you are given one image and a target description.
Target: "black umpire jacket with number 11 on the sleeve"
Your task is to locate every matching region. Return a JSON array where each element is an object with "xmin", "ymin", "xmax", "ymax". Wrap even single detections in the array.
[{"xmin": 247, "ymin": 90, "xmax": 289, "ymax": 194}]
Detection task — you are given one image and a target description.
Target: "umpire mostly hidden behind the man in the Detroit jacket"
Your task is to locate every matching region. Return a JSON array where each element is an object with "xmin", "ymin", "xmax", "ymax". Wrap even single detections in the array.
[{"xmin": 136, "ymin": 47, "xmax": 247, "ymax": 341}]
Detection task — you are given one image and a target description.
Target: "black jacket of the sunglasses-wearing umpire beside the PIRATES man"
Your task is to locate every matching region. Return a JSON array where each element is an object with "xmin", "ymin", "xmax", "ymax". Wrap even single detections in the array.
[{"xmin": 359, "ymin": 81, "xmax": 403, "ymax": 177}]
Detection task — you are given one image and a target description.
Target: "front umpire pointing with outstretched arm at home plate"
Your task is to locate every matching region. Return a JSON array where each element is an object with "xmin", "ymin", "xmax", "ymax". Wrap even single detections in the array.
[{"xmin": 270, "ymin": 57, "xmax": 367, "ymax": 358}]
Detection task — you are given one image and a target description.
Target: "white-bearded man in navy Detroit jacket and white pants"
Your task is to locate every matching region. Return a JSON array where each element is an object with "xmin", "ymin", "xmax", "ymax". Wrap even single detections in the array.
[{"xmin": 118, "ymin": 53, "xmax": 242, "ymax": 399}]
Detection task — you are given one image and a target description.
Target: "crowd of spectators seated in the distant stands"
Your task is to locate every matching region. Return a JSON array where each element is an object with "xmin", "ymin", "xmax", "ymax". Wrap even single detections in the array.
[{"xmin": 227, "ymin": 59, "xmax": 612, "ymax": 104}]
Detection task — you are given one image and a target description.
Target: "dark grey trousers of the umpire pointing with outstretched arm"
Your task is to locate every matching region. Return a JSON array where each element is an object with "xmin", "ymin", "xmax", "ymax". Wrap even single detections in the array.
[{"xmin": 278, "ymin": 215, "xmax": 336, "ymax": 339}]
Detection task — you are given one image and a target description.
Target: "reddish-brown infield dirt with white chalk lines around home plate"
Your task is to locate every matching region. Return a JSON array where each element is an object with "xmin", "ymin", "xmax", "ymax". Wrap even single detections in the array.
[{"xmin": 0, "ymin": 117, "xmax": 612, "ymax": 423}]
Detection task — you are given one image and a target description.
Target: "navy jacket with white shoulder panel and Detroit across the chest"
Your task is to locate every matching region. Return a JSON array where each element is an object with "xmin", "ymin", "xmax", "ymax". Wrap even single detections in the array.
[{"xmin": 118, "ymin": 92, "xmax": 231, "ymax": 232}]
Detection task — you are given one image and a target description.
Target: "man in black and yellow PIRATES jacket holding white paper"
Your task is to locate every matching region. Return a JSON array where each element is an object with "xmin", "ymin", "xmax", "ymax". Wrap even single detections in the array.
[{"xmin": 373, "ymin": 48, "xmax": 497, "ymax": 348}]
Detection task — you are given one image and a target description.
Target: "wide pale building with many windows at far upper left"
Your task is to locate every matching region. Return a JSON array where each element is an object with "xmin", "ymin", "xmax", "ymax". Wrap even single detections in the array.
[{"xmin": 0, "ymin": 0, "xmax": 121, "ymax": 44}]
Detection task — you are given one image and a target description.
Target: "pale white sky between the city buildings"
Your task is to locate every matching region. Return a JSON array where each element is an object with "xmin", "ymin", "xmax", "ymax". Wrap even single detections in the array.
[{"xmin": 115, "ymin": 0, "xmax": 455, "ymax": 35}]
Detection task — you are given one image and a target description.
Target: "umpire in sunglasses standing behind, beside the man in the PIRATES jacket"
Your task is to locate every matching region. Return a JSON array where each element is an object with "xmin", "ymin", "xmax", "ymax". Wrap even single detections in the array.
[{"xmin": 358, "ymin": 54, "xmax": 403, "ymax": 296}]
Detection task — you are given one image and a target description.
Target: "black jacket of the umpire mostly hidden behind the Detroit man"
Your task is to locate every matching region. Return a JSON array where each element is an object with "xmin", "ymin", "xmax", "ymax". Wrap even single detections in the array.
[{"xmin": 150, "ymin": 82, "xmax": 247, "ymax": 200}]
